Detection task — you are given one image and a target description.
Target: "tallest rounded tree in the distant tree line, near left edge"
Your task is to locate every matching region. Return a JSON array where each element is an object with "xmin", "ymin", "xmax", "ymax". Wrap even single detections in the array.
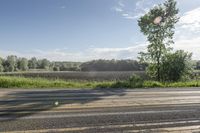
[{"xmin": 4, "ymin": 55, "xmax": 17, "ymax": 72}]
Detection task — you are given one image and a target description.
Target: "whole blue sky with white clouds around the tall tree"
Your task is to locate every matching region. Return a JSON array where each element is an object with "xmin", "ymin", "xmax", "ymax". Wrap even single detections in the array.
[{"xmin": 0, "ymin": 0, "xmax": 200, "ymax": 61}]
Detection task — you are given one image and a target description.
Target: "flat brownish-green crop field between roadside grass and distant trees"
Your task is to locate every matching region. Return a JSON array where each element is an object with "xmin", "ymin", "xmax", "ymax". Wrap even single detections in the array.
[{"xmin": 0, "ymin": 71, "xmax": 145, "ymax": 81}]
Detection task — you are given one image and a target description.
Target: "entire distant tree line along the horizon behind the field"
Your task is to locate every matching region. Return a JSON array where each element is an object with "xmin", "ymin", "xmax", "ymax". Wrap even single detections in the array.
[{"xmin": 0, "ymin": 55, "xmax": 200, "ymax": 72}]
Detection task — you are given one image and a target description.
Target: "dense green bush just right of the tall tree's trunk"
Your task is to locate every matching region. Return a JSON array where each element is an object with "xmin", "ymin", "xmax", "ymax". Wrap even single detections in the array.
[{"xmin": 161, "ymin": 50, "xmax": 192, "ymax": 82}]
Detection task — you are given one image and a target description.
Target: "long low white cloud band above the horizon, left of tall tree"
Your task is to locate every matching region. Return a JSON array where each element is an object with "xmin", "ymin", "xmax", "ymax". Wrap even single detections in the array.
[{"xmin": 0, "ymin": 44, "xmax": 146, "ymax": 61}]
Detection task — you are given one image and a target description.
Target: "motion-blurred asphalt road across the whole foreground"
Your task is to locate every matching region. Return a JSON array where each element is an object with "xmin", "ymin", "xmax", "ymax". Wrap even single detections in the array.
[{"xmin": 0, "ymin": 88, "xmax": 200, "ymax": 133}]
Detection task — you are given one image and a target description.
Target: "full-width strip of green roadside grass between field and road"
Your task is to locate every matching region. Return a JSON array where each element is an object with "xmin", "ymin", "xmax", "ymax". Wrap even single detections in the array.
[{"xmin": 0, "ymin": 76, "xmax": 200, "ymax": 89}]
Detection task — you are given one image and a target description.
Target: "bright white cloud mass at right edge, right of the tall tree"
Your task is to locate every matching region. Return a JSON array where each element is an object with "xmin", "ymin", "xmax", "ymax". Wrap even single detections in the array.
[{"xmin": 173, "ymin": 7, "xmax": 200, "ymax": 60}]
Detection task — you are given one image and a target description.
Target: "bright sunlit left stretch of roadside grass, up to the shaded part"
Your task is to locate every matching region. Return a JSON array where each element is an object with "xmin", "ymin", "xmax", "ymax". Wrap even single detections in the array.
[{"xmin": 0, "ymin": 76, "xmax": 113, "ymax": 88}]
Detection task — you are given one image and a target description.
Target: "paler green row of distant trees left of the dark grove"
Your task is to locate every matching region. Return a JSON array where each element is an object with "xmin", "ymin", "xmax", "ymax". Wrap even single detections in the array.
[{"xmin": 0, "ymin": 55, "xmax": 81, "ymax": 72}]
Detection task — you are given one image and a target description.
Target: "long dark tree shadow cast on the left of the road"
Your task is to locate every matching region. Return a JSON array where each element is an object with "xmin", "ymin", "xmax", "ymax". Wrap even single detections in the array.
[{"xmin": 0, "ymin": 89, "xmax": 125, "ymax": 122}]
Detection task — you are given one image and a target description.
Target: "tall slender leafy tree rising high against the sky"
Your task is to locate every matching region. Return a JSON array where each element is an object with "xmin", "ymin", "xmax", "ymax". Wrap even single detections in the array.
[{"xmin": 138, "ymin": 0, "xmax": 179, "ymax": 81}]
